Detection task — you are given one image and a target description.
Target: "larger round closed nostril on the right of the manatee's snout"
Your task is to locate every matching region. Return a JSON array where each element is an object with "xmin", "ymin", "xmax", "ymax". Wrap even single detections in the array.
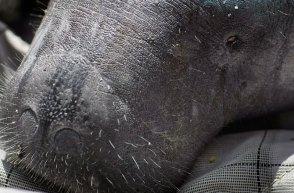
[{"xmin": 54, "ymin": 128, "xmax": 83, "ymax": 155}]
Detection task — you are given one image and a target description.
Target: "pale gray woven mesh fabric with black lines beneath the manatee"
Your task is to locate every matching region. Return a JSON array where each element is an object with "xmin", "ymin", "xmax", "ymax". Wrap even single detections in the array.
[{"xmin": 0, "ymin": 130, "xmax": 294, "ymax": 193}]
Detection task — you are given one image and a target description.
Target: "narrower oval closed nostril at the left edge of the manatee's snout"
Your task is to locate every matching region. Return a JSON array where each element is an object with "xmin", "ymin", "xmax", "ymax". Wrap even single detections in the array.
[{"xmin": 18, "ymin": 109, "xmax": 39, "ymax": 138}]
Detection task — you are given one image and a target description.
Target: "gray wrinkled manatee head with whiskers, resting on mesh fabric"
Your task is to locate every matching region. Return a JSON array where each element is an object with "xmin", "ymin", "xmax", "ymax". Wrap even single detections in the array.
[{"xmin": 1, "ymin": 0, "xmax": 294, "ymax": 193}]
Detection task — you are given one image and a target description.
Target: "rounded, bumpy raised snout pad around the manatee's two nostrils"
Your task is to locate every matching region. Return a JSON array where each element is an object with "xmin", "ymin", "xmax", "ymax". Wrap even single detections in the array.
[{"xmin": 17, "ymin": 57, "xmax": 131, "ymax": 157}]
